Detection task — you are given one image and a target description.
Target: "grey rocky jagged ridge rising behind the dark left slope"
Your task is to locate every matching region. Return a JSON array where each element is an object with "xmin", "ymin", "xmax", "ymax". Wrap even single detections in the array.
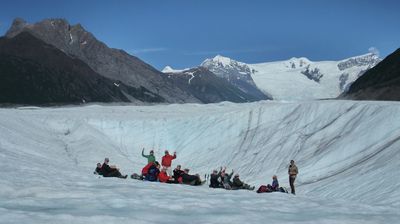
[{"xmin": 6, "ymin": 19, "xmax": 199, "ymax": 103}]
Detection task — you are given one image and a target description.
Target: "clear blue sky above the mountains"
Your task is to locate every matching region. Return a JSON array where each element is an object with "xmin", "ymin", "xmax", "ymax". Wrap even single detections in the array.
[{"xmin": 0, "ymin": 0, "xmax": 400, "ymax": 69}]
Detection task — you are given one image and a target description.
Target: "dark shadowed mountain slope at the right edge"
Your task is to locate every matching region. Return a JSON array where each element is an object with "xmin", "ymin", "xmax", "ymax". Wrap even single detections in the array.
[{"xmin": 344, "ymin": 49, "xmax": 400, "ymax": 100}]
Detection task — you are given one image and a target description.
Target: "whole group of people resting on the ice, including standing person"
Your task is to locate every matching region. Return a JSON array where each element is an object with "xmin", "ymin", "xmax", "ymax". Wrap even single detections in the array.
[{"xmin": 95, "ymin": 148, "xmax": 298, "ymax": 194}]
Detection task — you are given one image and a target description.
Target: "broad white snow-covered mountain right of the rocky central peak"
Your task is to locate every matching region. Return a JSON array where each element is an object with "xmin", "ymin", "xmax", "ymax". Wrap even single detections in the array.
[{"xmin": 249, "ymin": 53, "xmax": 381, "ymax": 100}]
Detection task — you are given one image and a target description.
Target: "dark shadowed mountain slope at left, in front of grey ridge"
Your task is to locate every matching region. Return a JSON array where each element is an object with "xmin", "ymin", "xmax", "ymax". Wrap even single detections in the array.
[{"xmin": 0, "ymin": 32, "xmax": 163, "ymax": 104}]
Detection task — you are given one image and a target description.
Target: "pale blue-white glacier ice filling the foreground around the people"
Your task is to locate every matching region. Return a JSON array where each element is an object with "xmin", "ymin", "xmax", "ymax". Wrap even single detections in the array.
[{"xmin": 0, "ymin": 101, "xmax": 400, "ymax": 224}]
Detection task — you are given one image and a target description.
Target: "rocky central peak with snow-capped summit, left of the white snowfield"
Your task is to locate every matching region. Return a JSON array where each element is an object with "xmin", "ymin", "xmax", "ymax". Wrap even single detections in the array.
[{"xmin": 162, "ymin": 62, "xmax": 271, "ymax": 103}]
